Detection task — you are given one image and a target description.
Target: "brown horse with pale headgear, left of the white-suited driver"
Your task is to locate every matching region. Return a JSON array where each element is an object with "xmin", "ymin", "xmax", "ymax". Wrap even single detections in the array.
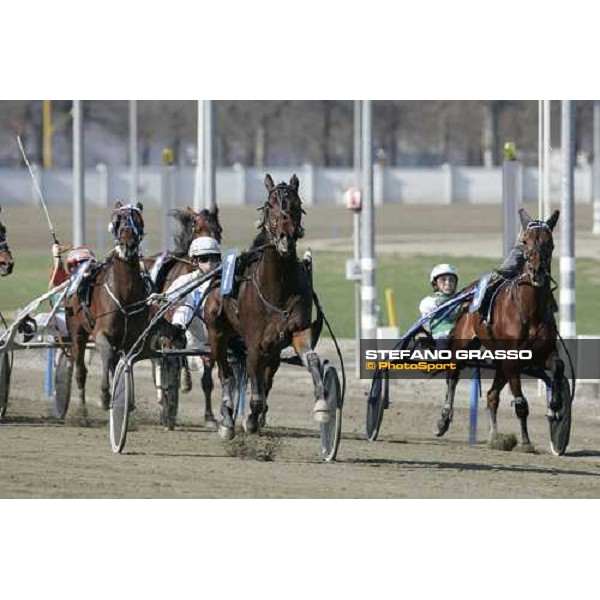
[{"xmin": 66, "ymin": 202, "xmax": 149, "ymax": 409}]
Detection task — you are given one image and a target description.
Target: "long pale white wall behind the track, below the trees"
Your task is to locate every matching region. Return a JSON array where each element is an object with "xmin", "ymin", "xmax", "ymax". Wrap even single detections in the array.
[{"xmin": 0, "ymin": 164, "xmax": 593, "ymax": 206}]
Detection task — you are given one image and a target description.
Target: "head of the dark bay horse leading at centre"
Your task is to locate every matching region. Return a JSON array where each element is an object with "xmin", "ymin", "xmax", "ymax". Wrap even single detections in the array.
[{"xmin": 260, "ymin": 173, "xmax": 306, "ymax": 256}]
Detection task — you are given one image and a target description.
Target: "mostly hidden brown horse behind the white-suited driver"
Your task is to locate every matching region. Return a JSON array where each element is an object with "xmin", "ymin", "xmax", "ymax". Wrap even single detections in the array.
[{"xmin": 143, "ymin": 206, "xmax": 223, "ymax": 429}]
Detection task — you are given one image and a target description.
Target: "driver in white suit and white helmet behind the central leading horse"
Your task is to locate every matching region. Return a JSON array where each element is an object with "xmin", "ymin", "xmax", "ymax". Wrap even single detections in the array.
[{"xmin": 165, "ymin": 237, "xmax": 221, "ymax": 348}]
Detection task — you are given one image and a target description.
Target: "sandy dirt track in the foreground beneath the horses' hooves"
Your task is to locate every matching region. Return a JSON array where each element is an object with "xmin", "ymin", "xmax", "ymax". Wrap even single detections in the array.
[{"xmin": 0, "ymin": 340, "xmax": 600, "ymax": 498}]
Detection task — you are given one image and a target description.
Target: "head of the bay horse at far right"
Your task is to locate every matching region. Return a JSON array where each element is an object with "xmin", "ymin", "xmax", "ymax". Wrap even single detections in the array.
[{"xmin": 519, "ymin": 209, "xmax": 560, "ymax": 287}]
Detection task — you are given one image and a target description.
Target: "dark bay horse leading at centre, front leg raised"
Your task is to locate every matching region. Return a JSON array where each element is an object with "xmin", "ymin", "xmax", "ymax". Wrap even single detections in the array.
[{"xmin": 204, "ymin": 174, "xmax": 329, "ymax": 439}]
